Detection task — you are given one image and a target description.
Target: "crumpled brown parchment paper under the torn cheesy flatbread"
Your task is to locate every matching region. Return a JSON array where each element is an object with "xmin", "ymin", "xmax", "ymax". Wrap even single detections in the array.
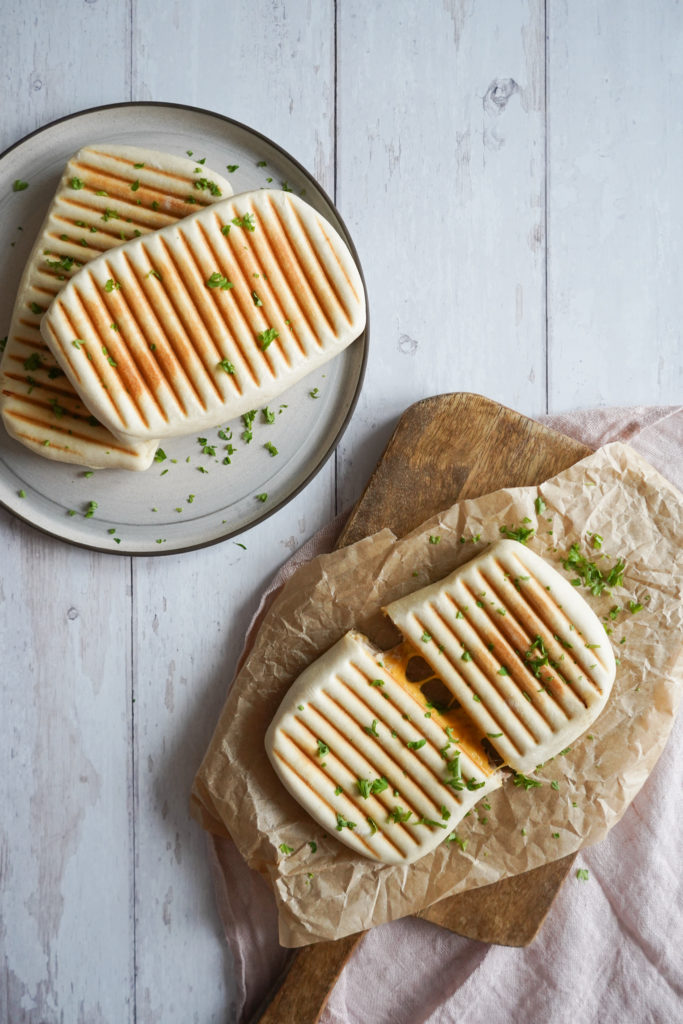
[{"xmin": 191, "ymin": 443, "xmax": 683, "ymax": 946}]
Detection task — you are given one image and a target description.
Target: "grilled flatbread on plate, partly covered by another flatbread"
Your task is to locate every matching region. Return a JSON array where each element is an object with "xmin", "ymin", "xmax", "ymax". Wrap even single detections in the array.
[{"xmin": 0, "ymin": 143, "xmax": 232, "ymax": 470}]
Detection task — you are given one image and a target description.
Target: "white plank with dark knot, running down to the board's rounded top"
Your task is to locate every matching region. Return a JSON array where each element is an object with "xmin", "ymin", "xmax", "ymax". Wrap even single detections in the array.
[{"xmin": 337, "ymin": 0, "xmax": 545, "ymax": 507}]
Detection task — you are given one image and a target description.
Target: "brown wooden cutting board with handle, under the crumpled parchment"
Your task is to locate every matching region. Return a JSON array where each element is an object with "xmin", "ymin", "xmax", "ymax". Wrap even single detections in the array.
[{"xmin": 256, "ymin": 394, "xmax": 591, "ymax": 1024}]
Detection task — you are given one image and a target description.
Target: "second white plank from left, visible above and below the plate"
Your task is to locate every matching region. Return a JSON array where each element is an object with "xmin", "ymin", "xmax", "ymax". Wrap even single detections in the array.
[{"xmin": 127, "ymin": 0, "xmax": 335, "ymax": 1024}]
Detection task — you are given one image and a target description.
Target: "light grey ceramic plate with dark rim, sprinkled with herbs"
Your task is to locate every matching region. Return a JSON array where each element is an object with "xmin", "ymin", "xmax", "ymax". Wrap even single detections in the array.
[{"xmin": 0, "ymin": 103, "xmax": 368, "ymax": 554}]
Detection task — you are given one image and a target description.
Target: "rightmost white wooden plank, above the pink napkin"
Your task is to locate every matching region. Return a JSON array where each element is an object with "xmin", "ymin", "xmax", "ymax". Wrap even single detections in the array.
[{"xmin": 548, "ymin": 0, "xmax": 683, "ymax": 411}]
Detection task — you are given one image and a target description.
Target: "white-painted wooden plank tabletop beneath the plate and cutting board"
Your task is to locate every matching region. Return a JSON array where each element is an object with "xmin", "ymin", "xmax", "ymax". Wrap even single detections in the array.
[{"xmin": 0, "ymin": 0, "xmax": 683, "ymax": 1024}]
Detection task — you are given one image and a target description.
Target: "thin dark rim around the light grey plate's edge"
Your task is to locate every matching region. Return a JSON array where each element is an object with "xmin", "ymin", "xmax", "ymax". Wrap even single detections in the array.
[{"xmin": 0, "ymin": 99, "xmax": 370, "ymax": 558}]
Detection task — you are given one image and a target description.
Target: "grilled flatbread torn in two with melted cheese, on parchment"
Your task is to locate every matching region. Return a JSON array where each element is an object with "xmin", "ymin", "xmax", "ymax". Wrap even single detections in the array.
[{"xmin": 265, "ymin": 541, "xmax": 615, "ymax": 864}]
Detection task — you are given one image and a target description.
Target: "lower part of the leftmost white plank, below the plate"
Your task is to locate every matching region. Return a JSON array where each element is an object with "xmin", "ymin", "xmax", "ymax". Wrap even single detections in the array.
[{"xmin": 0, "ymin": 512, "xmax": 133, "ymax": 1024}]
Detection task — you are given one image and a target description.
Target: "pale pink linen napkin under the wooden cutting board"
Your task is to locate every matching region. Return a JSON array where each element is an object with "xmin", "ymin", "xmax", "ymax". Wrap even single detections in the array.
[{"xmin": 209, "ymin": 407, "xmax": 683, "ymax": 1024}]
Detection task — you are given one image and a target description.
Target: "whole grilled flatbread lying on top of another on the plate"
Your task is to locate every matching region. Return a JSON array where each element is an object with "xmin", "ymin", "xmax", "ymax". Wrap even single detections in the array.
[{"xmin": 41, "ymin": 189, "xmax": 366, "ymax": 441}]
